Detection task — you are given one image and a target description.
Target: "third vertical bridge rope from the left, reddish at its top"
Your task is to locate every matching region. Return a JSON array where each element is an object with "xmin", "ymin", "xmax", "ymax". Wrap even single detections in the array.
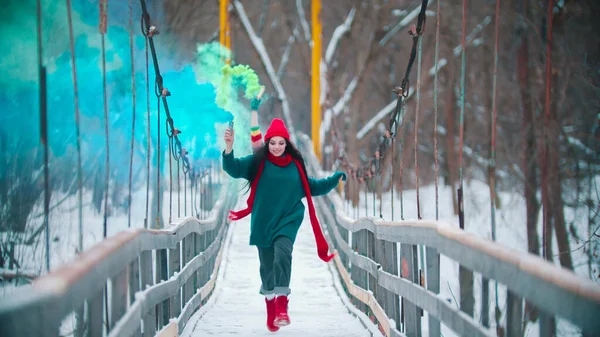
[{"xmin": 99, "ymin": 0, "xmax": 110, "ymax": 238}]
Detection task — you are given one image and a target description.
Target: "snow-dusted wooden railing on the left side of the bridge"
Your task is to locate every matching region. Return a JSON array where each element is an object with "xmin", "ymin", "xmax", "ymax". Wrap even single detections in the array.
[{"xmin": 0, "ymin": 177, "xmax": 237, "ymax": 337}]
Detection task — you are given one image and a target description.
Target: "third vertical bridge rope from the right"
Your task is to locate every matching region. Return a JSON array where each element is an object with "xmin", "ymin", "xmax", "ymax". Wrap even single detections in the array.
[{"xmin": 458, "ymin": 0, "xmax": 467, "ymax": 229}]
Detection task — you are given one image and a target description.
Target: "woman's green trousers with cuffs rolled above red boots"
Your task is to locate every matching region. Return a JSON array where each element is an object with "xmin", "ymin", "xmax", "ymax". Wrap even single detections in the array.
[{"xmin": 257, "ymin": 236, "xmax": 294, "ymax": 296}]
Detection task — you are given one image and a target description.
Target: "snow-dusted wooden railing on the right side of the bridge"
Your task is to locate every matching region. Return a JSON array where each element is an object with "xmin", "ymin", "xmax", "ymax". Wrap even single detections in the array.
[{"xmin": 299, "ymin": 135, "xmax": 600, "ymax": 337}]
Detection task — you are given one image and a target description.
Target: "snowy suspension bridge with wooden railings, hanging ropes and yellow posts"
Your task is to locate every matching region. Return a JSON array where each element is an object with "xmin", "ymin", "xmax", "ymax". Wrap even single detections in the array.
[{"xmin": 0, "ymin": 0, "xmax": 600, "ymax": 337}]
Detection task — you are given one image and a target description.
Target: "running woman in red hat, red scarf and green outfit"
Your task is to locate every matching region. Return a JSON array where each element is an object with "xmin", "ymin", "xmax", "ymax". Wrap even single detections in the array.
[{"xmin": 223, "ymin": 118, "xmax": 346, "ymax": 332}]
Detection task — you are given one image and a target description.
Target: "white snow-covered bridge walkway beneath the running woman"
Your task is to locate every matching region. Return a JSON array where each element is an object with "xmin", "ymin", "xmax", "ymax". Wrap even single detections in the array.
[{"xmin": 182, "ymin": 193, "xmax": 381, "ymax": 337}]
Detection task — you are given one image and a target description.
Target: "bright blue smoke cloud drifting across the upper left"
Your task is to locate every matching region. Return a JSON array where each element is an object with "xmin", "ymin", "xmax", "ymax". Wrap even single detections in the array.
[{"xmin": 0, "ymin": 0, "xmax": 232, "ymax": 189}]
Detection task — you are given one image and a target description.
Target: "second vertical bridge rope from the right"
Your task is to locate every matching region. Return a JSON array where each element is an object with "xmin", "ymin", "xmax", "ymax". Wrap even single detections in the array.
[{"xmin": 490, "ymin": 0, "xmax": 500, "ymax": 326}]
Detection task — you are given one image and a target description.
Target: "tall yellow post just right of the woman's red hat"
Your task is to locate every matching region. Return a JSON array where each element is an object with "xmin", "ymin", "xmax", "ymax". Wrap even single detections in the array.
[{"xmin": 311, "ymin": 0, "xmax": 322, "ymax": 162}]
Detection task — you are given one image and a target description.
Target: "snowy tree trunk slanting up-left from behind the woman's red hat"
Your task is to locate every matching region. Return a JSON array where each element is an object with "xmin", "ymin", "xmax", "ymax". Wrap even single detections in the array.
[{"xmin": 233, "ymin": 0, "xmax": 296, "ymax": 142}]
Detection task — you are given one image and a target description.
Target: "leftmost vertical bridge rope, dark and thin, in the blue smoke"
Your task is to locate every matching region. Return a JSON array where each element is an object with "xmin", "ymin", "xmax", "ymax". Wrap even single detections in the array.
[{"xmin": 36, "ymin": 0, "xmax": 50, "ymax": 273}]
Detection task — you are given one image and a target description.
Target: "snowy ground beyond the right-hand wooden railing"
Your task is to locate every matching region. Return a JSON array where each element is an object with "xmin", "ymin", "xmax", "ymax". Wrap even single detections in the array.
[{"xmin": 344, "ymin": 176, "xmax": 589, "ymax": 337}]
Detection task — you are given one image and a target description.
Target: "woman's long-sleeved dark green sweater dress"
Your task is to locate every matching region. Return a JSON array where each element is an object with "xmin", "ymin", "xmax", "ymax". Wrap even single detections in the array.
[{"xmin": 223, "ymin": 151, "xmax": 345, "ymax": 247}]
